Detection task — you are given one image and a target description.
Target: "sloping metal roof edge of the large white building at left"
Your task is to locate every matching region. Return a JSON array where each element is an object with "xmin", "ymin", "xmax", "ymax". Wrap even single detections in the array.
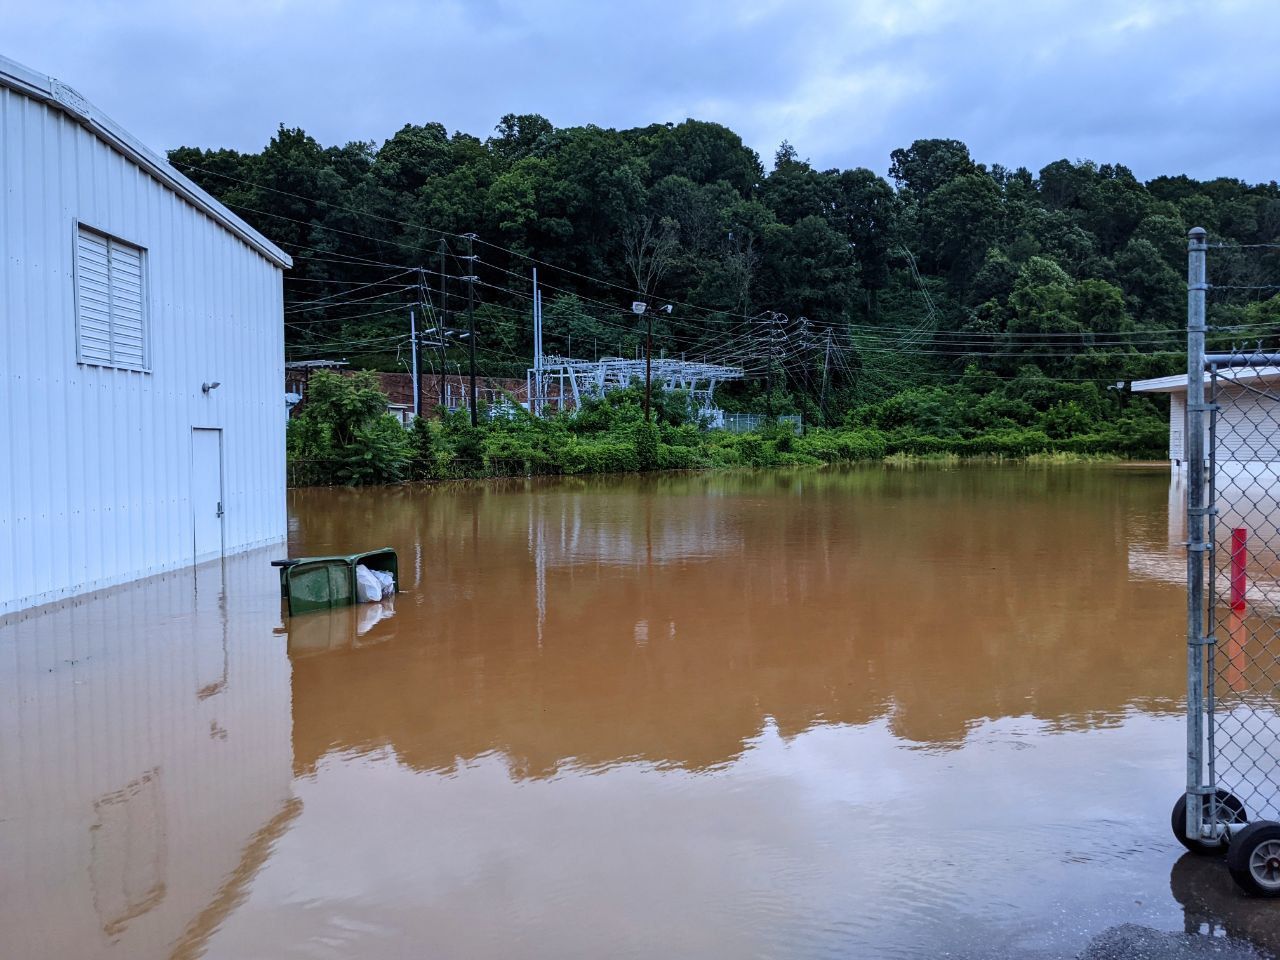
[{"xmin": 0, "ymin": 56, "xmax": 293, "ymax": 270}]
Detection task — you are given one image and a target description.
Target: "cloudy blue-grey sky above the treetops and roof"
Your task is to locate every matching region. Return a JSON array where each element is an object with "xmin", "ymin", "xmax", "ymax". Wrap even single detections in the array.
[{"xmin": 0, "ymin": 0, "xmax": 1280, "ymax": 180}]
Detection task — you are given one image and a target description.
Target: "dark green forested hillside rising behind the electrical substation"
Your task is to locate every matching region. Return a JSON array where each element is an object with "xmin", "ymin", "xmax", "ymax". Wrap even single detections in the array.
[{"xmin": 170, "ymin": 115, "xmax": 1280, "ymax": 436}]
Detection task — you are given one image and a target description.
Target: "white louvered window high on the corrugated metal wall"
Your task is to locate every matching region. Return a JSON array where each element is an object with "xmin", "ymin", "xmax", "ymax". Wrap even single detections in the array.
[{"xmin": 76, "ymin": 227, "xmax": 150, "ymax": 370}]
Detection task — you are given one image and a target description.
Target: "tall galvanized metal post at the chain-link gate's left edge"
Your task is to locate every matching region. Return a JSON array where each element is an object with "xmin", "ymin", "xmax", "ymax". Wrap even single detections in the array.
[{"xmin": 1187, "ymin": 227, "xmax": 1212, "ymax": 837}]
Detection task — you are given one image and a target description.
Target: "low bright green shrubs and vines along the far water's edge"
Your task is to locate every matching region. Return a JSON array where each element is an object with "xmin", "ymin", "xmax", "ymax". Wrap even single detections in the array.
[{"xmin": 289, "ymin": 371, "xmax": 1165, "ymax": 485}]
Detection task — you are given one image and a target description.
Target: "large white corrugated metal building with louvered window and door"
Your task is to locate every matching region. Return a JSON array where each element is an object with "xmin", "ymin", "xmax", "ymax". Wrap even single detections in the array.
[{"xmin": 0, "ymin": 58, "xmax": 292, "ymax": 614}]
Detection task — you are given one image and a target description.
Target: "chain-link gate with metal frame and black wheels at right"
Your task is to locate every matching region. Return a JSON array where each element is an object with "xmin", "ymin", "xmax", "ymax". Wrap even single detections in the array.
[{"xmin": 1171, "ymin": 227, "xmax": 1280, "ymax": 897}]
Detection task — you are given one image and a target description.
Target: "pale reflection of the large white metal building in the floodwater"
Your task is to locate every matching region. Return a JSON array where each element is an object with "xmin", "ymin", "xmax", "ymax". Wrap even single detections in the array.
[{"xmin": 0, "ymin": 554, "xmax": 297, "ymax": 960}]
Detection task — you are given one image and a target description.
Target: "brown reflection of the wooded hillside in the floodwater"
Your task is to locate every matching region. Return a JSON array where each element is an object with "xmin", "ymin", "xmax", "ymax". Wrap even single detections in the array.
[{"xmin": 291, "ymin": 468, "xmax": 1181, "ymax": 776}]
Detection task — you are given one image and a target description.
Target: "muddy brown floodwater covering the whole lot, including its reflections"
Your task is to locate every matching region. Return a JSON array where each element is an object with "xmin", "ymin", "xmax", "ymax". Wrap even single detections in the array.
[{"xmin": 0, "ymin": 466, "xmax": 1280, "ymax": 960}]
